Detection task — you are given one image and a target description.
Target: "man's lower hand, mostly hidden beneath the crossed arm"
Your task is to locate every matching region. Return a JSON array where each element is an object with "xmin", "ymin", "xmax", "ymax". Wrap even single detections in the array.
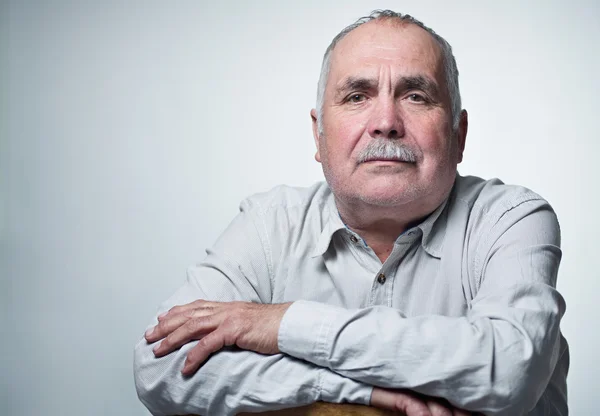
[{"xmin": 371, "ymin": 387, "xmax": 471, "ymax": 416}]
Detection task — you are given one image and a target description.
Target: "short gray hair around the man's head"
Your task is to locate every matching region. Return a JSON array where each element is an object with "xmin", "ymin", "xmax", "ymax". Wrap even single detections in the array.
[{"xmin": 317, "ymin": 10, "xmax": 462, "ymax": 133}]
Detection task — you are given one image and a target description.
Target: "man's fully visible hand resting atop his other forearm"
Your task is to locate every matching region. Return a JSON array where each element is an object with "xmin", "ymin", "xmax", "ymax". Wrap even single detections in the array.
[{"xmin": 145, "ymin": 300, "xmax": 291, "ymax": 375}]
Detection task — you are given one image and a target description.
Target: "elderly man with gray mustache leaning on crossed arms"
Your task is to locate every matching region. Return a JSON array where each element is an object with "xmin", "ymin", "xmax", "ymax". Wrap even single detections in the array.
[{"xmin": 135, "ymin": 11, "xmax": 569, "ymax": 416}]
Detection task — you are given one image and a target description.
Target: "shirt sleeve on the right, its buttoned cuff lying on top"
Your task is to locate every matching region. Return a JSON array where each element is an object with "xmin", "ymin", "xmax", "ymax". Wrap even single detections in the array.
[{"xmin": 278, "ymin": 197, "xmax": 565, "ymax": 415}]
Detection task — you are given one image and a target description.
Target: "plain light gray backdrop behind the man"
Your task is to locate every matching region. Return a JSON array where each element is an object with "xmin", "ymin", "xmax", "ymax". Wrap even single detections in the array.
[{"xmin": 0, "ymin": 0, "xmax": 600, "ymax": 416}]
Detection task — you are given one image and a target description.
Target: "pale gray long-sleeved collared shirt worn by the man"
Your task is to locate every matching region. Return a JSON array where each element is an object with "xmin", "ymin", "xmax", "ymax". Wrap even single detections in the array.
[{"xmin": 135, "ymin": 175, "xmax": 569, "ymax": 416}]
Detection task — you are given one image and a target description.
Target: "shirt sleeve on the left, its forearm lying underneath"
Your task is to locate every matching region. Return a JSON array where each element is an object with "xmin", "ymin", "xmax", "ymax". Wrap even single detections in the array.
[{"xmin": 134, "ymin": 199, "xmax": 372, "ymax": 416}]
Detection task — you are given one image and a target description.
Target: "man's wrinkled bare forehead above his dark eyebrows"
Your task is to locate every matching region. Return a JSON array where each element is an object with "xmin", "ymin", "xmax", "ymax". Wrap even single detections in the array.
[{"xmin": 328, "ymin": 20, "xmax": 443, "ymax": 88}]
